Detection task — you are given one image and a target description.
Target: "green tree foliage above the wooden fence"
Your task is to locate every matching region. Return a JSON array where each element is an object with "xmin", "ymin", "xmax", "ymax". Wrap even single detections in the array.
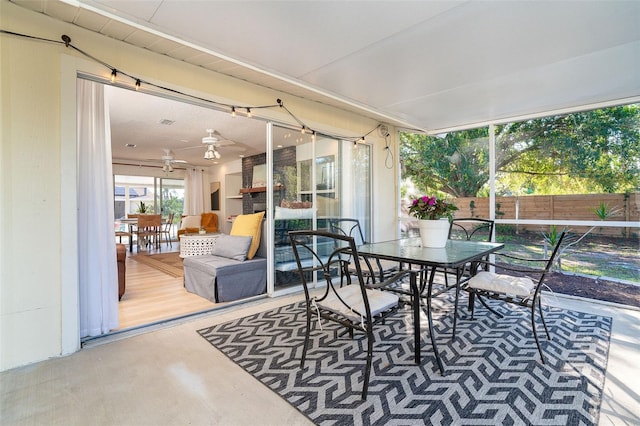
[{"xmin": 401, "ymin": 104, "xmax": 640, "ymax": 197}]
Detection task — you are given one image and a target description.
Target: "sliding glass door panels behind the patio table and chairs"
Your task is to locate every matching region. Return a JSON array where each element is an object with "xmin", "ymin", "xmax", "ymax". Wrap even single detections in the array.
[{"xmin": 271, "ymin": 125, "xmax": 371, "ymax": 292}]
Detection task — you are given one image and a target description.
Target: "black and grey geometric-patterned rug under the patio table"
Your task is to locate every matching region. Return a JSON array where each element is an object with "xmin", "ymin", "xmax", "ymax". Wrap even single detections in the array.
[{"xmin": 198, "ymin": 297, "xmax": 611, "ymax": 425}]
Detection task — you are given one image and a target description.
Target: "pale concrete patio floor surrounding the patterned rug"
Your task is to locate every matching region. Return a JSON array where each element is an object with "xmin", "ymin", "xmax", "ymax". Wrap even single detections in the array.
[{"xmin": 0, "ymin": 294, "xmax": 640, "ymax": 425}]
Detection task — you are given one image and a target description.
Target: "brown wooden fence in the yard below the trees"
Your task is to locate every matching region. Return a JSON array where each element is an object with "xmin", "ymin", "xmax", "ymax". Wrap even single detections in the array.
[{"xmin": 454, "ymin": 192, "xmax": 640, "ymax": 238}]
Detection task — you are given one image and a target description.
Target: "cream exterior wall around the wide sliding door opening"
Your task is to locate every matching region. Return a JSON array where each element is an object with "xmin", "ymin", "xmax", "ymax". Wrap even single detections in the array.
[{"xmin": 0, "ymin": 0, "xmax": 397, "ymax": 371}]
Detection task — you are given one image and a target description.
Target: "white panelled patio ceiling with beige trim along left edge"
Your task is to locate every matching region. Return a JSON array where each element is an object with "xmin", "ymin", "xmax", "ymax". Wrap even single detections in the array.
[{"xmin": 14, "ymin": 0, "xmax": 640, "ymax": 132}]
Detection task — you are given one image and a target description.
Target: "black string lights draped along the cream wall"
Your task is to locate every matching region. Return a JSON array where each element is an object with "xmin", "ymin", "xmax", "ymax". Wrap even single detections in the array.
[{"xmin": 0, "ymin": 29, "xmax": 396, "ymax": 143}]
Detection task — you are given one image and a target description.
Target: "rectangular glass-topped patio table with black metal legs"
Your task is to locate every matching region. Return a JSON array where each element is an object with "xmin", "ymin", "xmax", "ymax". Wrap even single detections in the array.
[{"xmin": 358, "ymin": 238, "xmax": 504, "ymax": 374}]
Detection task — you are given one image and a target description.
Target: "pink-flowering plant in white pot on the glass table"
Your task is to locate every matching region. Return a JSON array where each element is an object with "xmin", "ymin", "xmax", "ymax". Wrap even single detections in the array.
[{"xmin": 409, "ymin": 195, "xmax": 458, "ymax": 248}]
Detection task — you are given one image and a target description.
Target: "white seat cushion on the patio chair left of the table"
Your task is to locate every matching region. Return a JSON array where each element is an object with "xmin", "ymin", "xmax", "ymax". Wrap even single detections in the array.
[{"xmin": 317, "ymin": 284, "xmax": 399, "ymax": 322}]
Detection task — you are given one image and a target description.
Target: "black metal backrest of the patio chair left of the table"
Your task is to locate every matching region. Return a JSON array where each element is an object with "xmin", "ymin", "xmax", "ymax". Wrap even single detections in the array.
[{"xmin": 289, "ymin": 230, "xmax": 370, "ymax": 306}]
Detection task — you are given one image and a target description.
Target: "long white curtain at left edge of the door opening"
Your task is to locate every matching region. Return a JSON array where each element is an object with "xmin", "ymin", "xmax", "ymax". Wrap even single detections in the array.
[{"xmin": 77, "ymin": 79, "xmax": 118, "ymax": 337}]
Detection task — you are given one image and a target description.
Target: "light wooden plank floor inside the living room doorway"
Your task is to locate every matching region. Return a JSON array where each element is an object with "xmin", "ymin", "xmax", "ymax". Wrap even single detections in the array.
[{"xmin": 119, "ymin": 241, "xmax": 216, "ymax": 330}]
